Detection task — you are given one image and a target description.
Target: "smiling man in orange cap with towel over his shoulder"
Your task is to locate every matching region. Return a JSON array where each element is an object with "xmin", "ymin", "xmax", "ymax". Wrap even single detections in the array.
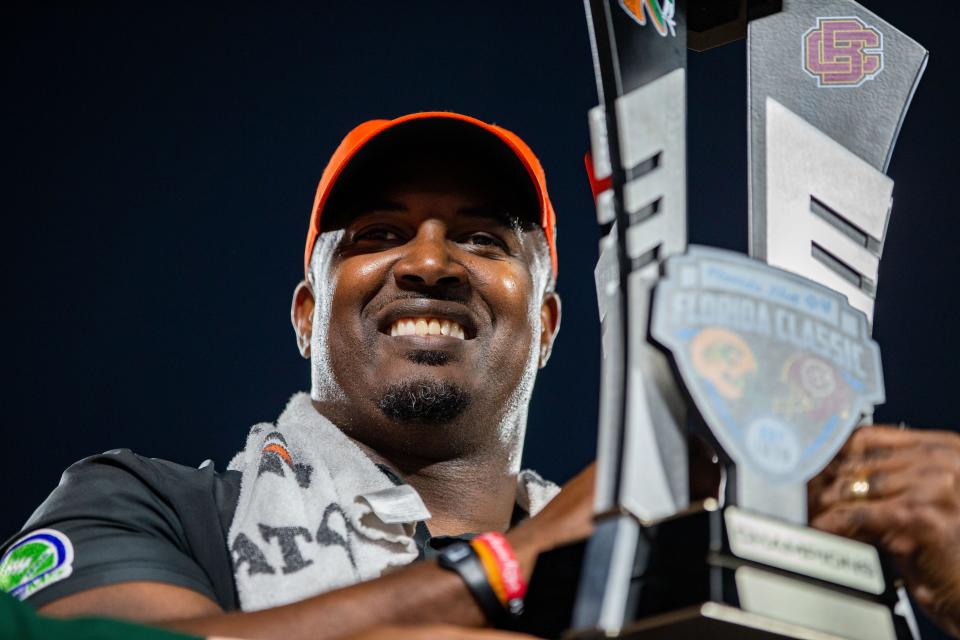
[{"xmin": 0, "ymin": 112, "xmax": 592, "ymax": 639}]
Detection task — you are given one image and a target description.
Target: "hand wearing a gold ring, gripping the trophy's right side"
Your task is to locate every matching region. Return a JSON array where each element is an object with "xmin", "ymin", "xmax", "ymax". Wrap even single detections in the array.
[{"xmin": 810, "ymin": 426, "xmax": 960, "ymax": 637}]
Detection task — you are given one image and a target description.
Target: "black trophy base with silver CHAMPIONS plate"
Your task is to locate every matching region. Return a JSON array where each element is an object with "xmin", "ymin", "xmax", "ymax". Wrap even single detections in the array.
[{"xmin": 517, "ymin": 503, "xmax": 915, "ymax": 640}]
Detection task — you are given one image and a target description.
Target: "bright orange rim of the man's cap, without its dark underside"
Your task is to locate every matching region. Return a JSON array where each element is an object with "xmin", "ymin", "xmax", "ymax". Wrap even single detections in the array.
[{"xmin": 303, "ymin": 111, "xmax": 557, "ymax": 277}]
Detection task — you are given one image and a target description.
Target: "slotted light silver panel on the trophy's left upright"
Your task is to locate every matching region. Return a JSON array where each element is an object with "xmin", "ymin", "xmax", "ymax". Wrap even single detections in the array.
[{"xmin": 616, "ymin": 68, "xmax": 689, "ymax": 520}]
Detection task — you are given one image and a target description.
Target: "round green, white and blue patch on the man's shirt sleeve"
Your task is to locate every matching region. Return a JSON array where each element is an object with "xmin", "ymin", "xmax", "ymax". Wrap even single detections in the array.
[{"xmin": 0, "ymin": 529, "xmax": 73, "ymax": 600}]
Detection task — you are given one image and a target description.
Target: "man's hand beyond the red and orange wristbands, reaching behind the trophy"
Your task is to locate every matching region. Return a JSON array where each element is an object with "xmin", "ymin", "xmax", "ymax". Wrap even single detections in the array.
[{"xmin": 507, "ymin": 462, "xmax": 597, "ymax": 580}]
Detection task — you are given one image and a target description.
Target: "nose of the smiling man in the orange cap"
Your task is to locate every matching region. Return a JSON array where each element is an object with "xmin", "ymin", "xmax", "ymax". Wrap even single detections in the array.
[{"xmin": 394, "ymin": 221, "xmax": 467, "ymax": 289}]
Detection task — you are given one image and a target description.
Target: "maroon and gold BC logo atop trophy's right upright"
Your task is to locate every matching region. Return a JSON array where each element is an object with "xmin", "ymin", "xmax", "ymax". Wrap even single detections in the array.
[{"xmin": 803, "ymin": 18, "xmax": 883, "ymax": 87}]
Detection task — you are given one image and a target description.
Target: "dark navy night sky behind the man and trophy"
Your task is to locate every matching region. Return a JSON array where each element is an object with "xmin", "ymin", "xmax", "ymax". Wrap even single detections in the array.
[{"xmin": 0, "ymin": 0, "xmax": 960, "ymax": 636}]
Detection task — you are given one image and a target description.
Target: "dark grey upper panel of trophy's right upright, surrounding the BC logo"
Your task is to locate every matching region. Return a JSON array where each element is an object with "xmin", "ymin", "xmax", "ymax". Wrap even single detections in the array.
[{"xmin": 747, "ymin": 0, "xmax": 928, "ymax": 259}]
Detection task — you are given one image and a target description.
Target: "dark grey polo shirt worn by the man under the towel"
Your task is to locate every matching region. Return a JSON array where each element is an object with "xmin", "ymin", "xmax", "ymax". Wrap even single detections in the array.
[{"xmin": 0, "ymin": 449, "xmax": 527, "ymax": 611}]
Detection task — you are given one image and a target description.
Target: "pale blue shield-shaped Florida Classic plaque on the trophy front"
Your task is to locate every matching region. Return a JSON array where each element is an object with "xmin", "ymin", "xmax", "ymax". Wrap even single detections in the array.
[{"xmin": 650, "ymin": 247, "xmax": 884, "ymax": 484}]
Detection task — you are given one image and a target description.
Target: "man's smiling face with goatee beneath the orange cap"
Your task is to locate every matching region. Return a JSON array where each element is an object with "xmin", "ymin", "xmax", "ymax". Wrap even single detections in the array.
[{"xmin": 294, "ymin": 145, "xmax": 559, "ymax": 464}]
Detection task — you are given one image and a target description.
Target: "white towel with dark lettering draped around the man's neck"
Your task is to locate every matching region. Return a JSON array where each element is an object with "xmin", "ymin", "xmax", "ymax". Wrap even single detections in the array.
[{"xmin": 227, "ymin": 393, "xmax": 559, "ymax": 611}]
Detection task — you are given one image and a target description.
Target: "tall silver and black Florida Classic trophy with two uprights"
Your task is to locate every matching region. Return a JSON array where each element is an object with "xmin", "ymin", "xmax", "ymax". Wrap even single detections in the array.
[{"xmin": 556, "ymin": 0, "xmax": 927, "ymax": 640}]
